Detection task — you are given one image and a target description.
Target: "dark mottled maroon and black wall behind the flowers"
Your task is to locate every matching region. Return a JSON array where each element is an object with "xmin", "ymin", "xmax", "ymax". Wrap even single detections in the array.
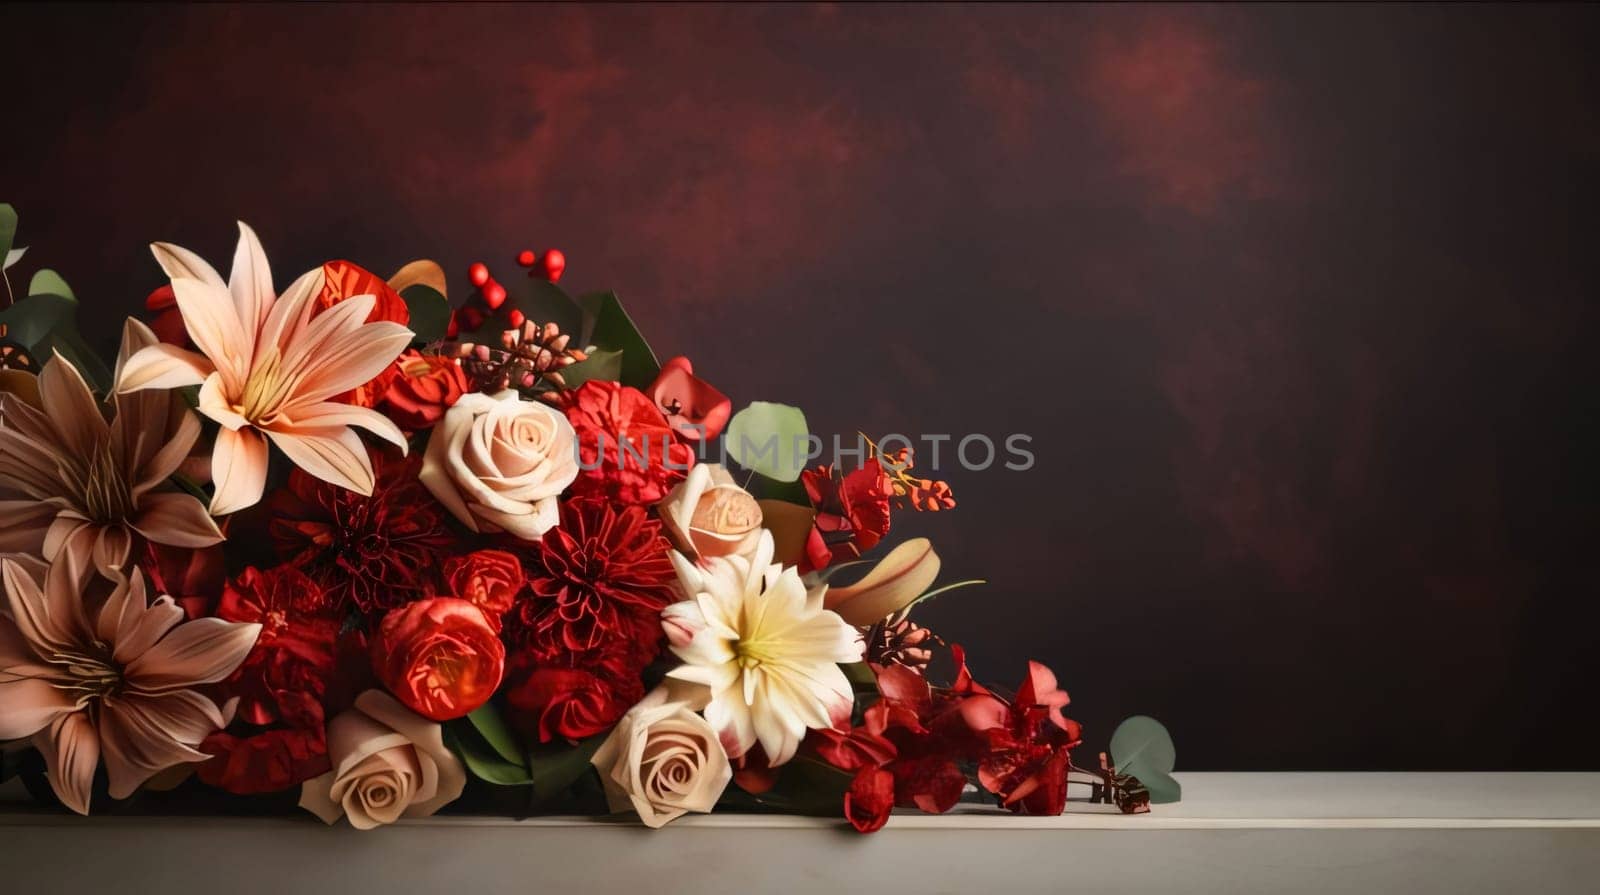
[{"xmin": 0, "ymin": 5, "xmax": 1600, "ymax": 770}]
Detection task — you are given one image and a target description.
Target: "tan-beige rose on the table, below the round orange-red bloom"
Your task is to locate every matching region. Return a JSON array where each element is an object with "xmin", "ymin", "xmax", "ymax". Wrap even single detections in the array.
[{"xmin": 299, "ymin": 690, "xmax": 467, "ymax": 829}]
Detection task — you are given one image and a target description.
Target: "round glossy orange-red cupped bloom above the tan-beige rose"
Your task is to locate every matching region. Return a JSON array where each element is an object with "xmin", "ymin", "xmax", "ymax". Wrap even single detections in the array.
[{"xmin": 373, "ymin": 597, "xmax": 506, "ymax": 720}]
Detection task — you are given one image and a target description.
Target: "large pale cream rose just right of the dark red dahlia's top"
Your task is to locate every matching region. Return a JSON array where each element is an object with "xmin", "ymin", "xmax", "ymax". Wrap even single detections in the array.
[{"xmin": 421, "ymin": 391, "xmax": 578, "ymax": 541}]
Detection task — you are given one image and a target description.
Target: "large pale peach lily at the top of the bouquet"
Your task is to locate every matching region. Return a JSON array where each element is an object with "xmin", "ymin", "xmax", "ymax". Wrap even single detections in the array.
[{"xmin": 117, "ymin": 223, "xmax": 413, "ymax": 516}]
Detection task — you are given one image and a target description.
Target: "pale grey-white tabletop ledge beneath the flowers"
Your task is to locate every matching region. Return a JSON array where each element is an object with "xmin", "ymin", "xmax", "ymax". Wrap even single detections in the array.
[{"xmin": 0, "ymin": 773, "xmax": 1600, "ymax": 895}]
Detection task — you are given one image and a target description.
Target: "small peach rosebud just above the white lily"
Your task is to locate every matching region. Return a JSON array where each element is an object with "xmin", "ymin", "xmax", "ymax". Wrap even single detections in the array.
[{"xmin": 659, "ymin": 463, "xmax": 762, "ymax": 559}]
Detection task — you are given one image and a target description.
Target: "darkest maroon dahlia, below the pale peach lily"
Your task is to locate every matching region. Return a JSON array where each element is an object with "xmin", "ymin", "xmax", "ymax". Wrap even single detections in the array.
[{"xmin": 267, "ymin": 450, "xmax": 451, "ymax": 612}]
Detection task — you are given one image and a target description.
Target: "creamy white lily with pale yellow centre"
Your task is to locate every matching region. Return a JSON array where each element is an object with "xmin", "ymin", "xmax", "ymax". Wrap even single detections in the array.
[{"xmin": 662, "ymin": 532, "xmax": 862, "ymax": 765}]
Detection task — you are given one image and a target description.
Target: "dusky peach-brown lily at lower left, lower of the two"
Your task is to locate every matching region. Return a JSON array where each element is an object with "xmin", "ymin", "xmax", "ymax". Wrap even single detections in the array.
[{"xmin": 0, "ymin": 551, "xmax": 261, "ymax": 813}]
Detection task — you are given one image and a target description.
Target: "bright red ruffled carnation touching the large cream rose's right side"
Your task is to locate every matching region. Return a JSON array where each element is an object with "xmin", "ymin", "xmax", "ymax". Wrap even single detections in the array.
[{"xmin": 563, "ymin": 379, "xmax": 694, "ymax": 504}]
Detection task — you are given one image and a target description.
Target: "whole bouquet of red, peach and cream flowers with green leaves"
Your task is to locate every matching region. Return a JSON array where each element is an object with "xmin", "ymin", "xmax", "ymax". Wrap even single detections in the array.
[{"xmin": 0, "ymin": 207, "xmax": 1176, "ymax": 831}]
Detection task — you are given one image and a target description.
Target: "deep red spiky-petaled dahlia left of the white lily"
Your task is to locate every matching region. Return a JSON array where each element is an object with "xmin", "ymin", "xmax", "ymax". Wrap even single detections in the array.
[{"xmin": 515, "ymin": 500, "xmax": 678, "ymax": 668}]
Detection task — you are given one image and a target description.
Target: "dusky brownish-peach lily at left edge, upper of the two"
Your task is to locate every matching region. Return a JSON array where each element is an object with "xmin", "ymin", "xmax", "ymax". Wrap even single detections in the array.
[{"xmin": 0, "ymin": 320, "xmax": 222, "ymax": 568}]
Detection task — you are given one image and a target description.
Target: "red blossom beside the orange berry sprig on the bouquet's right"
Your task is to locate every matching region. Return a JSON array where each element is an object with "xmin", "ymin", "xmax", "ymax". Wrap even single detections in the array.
[{"xmin": 800, "ymin": 461, "xmax": 894, "ymax": 572}]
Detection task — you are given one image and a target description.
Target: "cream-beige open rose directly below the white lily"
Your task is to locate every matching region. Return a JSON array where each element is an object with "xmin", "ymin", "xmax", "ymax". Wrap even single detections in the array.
[{"xmin": 590, "ymin": 687, "xmax": 733, "ymax": 828}]
